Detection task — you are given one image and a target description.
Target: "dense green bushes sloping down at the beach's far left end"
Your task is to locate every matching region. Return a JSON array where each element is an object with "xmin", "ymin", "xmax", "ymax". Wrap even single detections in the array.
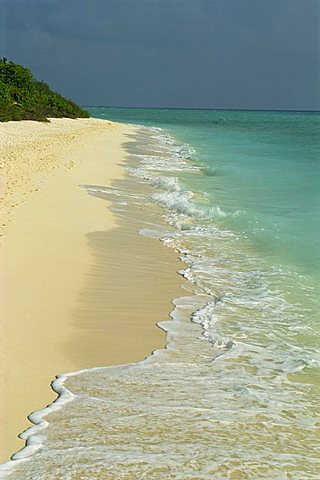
[{"xmin": 0, "ymin": 58, "xmax": 90, "ymax": 122}]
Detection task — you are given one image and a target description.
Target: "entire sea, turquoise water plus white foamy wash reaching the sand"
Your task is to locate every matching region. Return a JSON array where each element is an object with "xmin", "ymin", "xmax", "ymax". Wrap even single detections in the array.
[{"xmin": 1, "ymin": 107, "xmax": 320, "ymax": 480}]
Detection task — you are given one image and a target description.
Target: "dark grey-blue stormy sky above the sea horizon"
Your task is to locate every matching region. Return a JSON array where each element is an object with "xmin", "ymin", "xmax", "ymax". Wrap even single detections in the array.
[{"xmin": 0, "ymin": 0, "xmax": 320, "ymax": 110}]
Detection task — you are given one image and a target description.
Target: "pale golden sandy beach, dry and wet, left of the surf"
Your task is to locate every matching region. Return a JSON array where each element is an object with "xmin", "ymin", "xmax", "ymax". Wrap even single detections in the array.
[{"xmin": 0, "ymin": 119, "xmax": 181, "ymax": 461}]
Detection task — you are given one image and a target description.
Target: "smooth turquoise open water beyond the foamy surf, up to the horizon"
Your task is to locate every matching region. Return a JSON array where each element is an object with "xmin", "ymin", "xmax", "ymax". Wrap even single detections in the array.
[{"xmin": 91, "ymin": 108, "xmax": 320, "ymax": 279}]
